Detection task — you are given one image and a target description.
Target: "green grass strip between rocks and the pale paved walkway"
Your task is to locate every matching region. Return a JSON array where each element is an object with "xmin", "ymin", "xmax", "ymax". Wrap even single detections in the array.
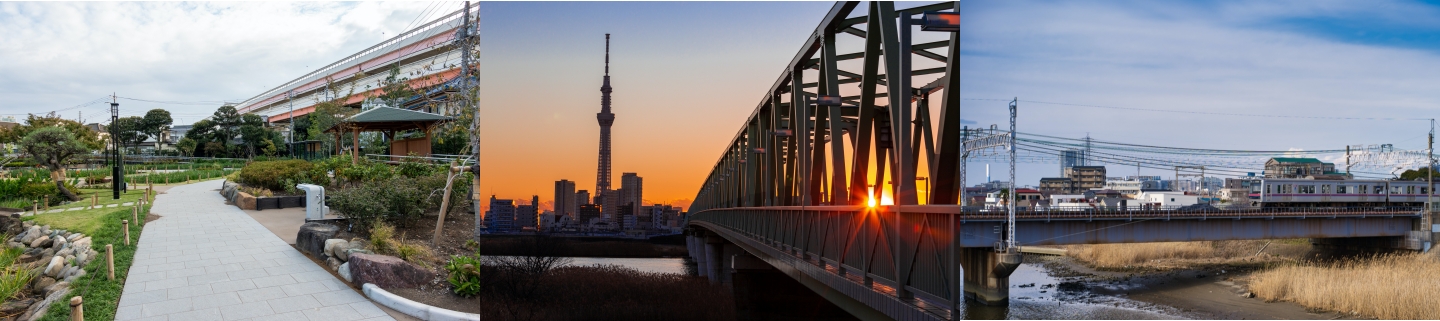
[{"xmin": 30, "ymin": 206, "xmax": 148, "ymax": 321}]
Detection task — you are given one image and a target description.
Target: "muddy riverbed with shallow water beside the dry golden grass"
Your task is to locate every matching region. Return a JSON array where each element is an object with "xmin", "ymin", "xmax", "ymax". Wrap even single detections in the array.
[{"xmin": 1019, "ymin": 255, "xmax": 1354, "ymax": 320}]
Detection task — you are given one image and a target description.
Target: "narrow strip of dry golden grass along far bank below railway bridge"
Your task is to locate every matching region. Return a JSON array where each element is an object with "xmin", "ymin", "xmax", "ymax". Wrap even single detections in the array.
[{"xmin": 1067, "ymin": 240, "xmax": 1309, "ymax": 269}]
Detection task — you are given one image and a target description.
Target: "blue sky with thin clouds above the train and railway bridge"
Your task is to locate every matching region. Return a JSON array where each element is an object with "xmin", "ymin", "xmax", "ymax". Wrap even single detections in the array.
[{"xmin": 960, "ymin": 1, "xmax": 1440, "ymax": 184}]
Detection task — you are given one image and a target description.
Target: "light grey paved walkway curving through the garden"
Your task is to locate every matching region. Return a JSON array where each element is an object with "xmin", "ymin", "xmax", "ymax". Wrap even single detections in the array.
[{"xmin": 115, "ymin": 180, "xmax": 393, "ymax": 321}]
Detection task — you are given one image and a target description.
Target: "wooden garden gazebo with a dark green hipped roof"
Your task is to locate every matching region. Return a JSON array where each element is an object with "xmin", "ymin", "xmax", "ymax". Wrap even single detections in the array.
[{"xmin": 325, "ymin": 107, "xmax": 455, "ymax": 163}]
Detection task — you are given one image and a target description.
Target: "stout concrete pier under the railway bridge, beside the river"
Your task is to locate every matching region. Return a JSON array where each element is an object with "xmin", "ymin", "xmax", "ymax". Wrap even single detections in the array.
[{"xmin": 959, "ymin": 248, "xmax": 1024, "ymax": 305}]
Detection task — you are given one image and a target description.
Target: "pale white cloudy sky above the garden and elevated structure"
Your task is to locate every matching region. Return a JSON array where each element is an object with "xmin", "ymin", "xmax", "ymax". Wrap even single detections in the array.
[{"xmin": 0, "ymin": 1, "xmax": 440, "ymax": 121}]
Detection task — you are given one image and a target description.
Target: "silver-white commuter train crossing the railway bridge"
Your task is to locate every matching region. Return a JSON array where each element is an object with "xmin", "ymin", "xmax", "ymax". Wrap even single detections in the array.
[{"xmin": 1250, "ymin": 178, "xmax": 1430, "ymax": 207}]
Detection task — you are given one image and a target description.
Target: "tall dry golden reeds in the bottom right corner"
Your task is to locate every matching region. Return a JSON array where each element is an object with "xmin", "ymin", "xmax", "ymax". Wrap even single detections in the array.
[{"xmin": 1250, "ymin": 253, "xmax": 1440, "ymax": 320}]
